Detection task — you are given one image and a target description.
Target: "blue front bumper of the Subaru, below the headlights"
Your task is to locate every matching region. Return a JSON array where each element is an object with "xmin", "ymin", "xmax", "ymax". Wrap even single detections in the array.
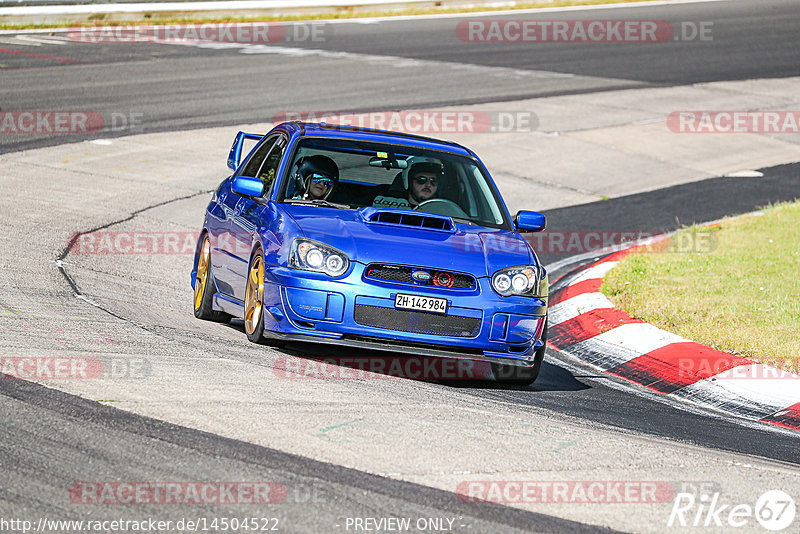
[{"xmin": 256, "ymin": 263, "xmax": 547, "ymax": 365}]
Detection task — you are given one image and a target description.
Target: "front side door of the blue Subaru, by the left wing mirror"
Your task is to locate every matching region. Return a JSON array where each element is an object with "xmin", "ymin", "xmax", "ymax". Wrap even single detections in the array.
[{"xmin": 229, "ymin": 134, "xmax": 287, "ymax": 300}]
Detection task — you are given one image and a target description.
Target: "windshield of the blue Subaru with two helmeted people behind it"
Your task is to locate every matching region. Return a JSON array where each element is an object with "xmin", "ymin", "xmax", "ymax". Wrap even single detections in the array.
[{"xmin": 281, "ymin": 137, "xmax": 510, "ymax": 228}]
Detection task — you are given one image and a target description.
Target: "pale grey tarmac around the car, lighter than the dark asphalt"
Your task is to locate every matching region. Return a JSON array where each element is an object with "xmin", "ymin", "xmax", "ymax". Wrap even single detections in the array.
[{"xmin": 0, "ymin": 78, "xmax": 800, "ymax": 532}]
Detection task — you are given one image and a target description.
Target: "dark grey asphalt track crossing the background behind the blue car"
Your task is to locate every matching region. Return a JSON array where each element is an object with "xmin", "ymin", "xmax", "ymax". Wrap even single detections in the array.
[{"xmin": 0, "ymin": 0, "xmax": 800, "ymax": 153}]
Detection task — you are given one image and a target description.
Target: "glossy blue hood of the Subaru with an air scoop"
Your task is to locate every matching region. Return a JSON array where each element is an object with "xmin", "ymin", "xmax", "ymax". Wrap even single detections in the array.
[{"xmin": 282, "ymin": 204, "xmax": 536, "ymax": 276}]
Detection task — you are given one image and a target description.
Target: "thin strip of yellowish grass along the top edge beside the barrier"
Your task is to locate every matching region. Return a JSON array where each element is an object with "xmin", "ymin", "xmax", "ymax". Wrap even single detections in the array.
[{"xmin": 0, "ymin": 0, "xmax": 664, "ymax": 30}]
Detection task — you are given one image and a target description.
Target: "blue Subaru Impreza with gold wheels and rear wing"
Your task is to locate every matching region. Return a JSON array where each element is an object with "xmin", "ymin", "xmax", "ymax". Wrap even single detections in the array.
[{"xmin": 191, "ymin": 122, "xmax": 548, "ymax": 384}]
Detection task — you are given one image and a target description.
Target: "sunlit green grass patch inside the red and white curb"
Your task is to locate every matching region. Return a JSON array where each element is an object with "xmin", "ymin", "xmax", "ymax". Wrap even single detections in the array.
[{"xmin": 602, "ymin": 202, "xmax": 800, "ymax": 372}]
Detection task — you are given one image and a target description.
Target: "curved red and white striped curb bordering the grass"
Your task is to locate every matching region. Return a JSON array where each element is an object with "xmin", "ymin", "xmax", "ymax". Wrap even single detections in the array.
[{"xmin": 547, "ymin": 249, "xmax": 800, "ymax": 430}]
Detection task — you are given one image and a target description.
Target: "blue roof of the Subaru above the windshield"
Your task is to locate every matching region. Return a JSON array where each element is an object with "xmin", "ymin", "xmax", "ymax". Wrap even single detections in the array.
[{"xmin": 275, "ymin": 121, "xmax": 477, "ymax": 157}]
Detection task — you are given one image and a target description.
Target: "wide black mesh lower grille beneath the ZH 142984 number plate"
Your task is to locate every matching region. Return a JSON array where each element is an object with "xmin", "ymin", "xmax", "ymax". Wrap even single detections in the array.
[{"xmin": 355, "ymin": 304, "xmax": 481, "ymax": 337}]
